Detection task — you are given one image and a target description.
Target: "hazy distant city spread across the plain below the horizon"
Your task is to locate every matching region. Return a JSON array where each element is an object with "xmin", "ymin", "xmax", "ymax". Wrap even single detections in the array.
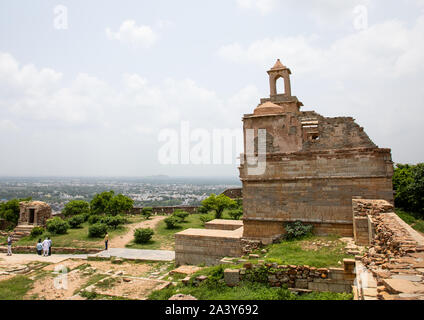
[{"xmin": 0, "ymin": 175, "xmax": 241, "ymax": 212}]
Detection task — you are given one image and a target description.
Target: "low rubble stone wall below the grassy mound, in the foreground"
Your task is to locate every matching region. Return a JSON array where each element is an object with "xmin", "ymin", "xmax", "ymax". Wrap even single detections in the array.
[{"xmin": 224, "ymin": 259, "xmax": 356, "ymax": 293}]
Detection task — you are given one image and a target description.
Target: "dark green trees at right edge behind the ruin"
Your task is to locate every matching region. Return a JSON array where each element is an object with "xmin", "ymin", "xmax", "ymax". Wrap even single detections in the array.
[{"xmin": 393, "ymin": 163, "xmax": 424, "ymax": 218}]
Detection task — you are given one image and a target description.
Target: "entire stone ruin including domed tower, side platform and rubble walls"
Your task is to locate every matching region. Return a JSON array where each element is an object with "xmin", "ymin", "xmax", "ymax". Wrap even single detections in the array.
[{"xmin": 175, "ymin": 60, "xmax": 424, "ymax": 300}]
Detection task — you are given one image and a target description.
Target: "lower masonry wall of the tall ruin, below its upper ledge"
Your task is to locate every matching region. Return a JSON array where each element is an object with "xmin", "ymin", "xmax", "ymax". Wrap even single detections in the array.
[{"xmin": 240, "ymin": 148, "xmax": 393, "ymax": 242}]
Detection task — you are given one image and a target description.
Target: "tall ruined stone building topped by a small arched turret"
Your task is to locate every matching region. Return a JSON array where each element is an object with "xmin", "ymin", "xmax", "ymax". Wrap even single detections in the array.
[{"xmin": 239, "ymin": 60, "xmax": 393, "ymax": 243}]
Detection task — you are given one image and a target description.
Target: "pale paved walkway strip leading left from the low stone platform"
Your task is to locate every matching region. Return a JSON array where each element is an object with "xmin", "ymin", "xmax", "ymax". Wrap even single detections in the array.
[{"xmin": 89, "ymin": 248, "xmax": 175, "ymax": 261}]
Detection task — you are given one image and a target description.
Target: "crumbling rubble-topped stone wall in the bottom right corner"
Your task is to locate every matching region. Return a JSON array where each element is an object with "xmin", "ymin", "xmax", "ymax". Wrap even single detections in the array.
[{"xmin": 354, "ymin": 200, "xmax": 424, "ymax": 300}]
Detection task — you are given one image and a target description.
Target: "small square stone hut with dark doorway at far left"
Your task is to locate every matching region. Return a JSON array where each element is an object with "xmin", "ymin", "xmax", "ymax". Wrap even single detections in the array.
[{"xmin": 18, "ymin": 201, "xmax": 52, "ymax": 227}]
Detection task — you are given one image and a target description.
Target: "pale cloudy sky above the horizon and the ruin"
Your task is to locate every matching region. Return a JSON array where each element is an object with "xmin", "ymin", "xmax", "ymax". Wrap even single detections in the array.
[{"xmin": 0, "ymin": 0, "xmax": 424, "ymax": 176}]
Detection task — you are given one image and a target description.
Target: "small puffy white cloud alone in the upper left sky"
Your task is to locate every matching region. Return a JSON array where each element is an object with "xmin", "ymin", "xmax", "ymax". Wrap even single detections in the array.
[{"xmin": 106, "ymin": 20, "xmax": 158, "ymax": 48}]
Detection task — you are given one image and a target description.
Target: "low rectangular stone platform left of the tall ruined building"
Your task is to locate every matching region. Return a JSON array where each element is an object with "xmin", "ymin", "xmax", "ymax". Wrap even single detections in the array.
[{"xmin": 175, "ymin": 228, "xmax": 243, "ymax": 265}]
